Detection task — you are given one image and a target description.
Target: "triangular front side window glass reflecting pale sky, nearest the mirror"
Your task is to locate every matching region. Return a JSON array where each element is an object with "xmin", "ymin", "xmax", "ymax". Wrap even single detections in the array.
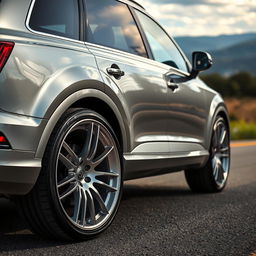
[{"xmin": 135, "ymin": 10, "xmax": 188, "ymax": 72}]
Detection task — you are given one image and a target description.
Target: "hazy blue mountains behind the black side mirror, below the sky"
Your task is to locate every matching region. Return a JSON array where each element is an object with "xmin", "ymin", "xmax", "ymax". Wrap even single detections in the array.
[{"xmin": 175, "ymin": 33, "xmax": 256, "ymax": 76}]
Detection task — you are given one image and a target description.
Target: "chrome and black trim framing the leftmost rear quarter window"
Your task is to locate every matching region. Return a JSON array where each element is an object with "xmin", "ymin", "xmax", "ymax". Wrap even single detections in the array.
[{"xmin": 25, "ymin": 0, "xmax": 84, "ymax": 44}]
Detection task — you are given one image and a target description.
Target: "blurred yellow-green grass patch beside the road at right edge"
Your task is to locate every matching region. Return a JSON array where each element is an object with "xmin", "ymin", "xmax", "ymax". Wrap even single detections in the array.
[{"xmin": 230, "ymin": 120, "xmax": 256, "ymax": 140}]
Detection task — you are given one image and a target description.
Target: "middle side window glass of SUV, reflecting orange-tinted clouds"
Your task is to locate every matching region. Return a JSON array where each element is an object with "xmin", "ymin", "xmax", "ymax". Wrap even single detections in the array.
[{"xmin": 86, "ymin": 0, "xmax": 147, "ymax": 57}]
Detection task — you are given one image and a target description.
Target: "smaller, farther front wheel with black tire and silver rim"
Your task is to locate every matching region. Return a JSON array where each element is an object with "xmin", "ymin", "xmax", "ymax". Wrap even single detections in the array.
[{"xmin": 185, "ymin": 116, "xmax": 230, "ymax": 193}]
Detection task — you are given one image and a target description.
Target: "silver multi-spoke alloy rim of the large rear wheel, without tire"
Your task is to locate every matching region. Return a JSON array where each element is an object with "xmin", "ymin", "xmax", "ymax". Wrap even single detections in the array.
[{"xmin": 56, "ymin": 119, "xmax": 121, "ymax": 231}]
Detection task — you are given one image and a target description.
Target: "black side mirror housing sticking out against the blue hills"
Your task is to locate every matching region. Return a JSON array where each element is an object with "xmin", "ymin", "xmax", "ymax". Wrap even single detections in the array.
[{"xmin": 192, "ymin": 52, "xmax": 212, "ymax": 74}]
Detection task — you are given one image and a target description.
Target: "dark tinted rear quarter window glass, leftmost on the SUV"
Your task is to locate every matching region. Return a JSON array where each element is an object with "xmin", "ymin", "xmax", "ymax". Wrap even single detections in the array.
[{"xmin": 29, "ymin": 0, "xmax": 79, "ymax": 40}]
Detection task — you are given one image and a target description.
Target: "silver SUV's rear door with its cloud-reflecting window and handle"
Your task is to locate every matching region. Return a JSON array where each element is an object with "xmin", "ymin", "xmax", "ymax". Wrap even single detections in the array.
[{"xmin": 86, "ymin": 0, "xmax": 172, "ymax": 155}]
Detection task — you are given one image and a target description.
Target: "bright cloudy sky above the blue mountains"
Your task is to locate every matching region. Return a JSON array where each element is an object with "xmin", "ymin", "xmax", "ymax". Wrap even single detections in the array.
[{"xmin": 137, "ymin": 0, "xmax": 256, "ymax": 36}]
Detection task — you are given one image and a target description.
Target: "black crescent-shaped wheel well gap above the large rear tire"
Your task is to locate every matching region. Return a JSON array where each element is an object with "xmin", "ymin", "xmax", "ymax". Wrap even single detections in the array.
[{"xmin": 70, "ymin": 97, "xmax": 123, "ymax": 149}]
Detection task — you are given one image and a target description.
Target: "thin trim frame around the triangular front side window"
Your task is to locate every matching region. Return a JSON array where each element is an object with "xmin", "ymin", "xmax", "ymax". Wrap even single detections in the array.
[{"xmin": 131, "ymin": 7, "xmax": 192, "ymax": 75}]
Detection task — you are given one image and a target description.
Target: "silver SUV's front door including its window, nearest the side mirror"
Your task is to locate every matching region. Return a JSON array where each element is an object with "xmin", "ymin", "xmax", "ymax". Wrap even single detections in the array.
[{"xmin": 135, "ymin": 10, "xmax": 207, "ymax": 152}]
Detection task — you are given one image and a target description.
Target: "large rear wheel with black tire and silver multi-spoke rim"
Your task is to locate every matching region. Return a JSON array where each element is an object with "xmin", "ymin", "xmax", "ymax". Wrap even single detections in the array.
[{"xmin": 16, "ymin": 109, "xmax": 123, "ymax": 240}]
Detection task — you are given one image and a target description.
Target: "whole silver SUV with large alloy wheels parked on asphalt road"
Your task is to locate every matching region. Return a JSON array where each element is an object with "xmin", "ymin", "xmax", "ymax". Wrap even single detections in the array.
[{"xmin": 0, "ymin": 0, "xmax": 230, "ymax": 240}]
